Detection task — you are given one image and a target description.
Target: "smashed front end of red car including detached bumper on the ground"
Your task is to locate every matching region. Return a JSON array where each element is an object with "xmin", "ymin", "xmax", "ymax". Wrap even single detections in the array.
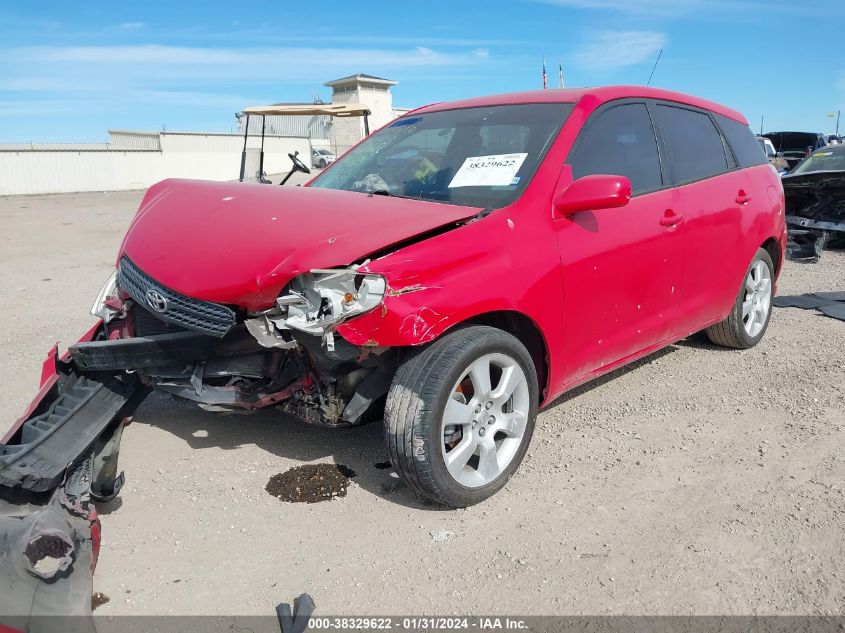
[{"xmin": 0, "ymin": 256, "xmax": 396, "ymax": 630}]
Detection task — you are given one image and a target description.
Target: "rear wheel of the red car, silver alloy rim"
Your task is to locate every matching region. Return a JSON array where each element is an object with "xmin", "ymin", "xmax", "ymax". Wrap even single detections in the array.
[{"xmin": 707, "ymin": 248, "xmax": 775, "ymax": 349}]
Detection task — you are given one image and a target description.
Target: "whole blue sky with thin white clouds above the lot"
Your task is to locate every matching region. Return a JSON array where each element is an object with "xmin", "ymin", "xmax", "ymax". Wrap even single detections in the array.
[{"xmin": 0, "ymin": 0, "xmax": 845, "ymax": 142}]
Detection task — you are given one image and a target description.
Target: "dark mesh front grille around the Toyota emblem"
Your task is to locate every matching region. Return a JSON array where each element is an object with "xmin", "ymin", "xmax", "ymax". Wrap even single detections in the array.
[{"xmin": 117, "ymin": 255, "xmax": 235, "ymax": 338}]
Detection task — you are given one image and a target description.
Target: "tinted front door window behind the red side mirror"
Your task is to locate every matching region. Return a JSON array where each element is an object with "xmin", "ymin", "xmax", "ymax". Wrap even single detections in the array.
[{"xmin": 567, "ymin": 103, "xmax": 663, "ymax": 193}]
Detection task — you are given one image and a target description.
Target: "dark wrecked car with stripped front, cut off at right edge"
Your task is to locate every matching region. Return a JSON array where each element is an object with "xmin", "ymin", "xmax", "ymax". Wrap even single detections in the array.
[{"xmin": 782, "ymin": 145, "xmax": 845, "ymax": 263}]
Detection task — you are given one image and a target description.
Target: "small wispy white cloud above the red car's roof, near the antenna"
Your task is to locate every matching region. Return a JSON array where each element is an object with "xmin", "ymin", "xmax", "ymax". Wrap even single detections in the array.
[{"xmin": 575, "ymin": 31, "xmax": 667, "ymax": 70}]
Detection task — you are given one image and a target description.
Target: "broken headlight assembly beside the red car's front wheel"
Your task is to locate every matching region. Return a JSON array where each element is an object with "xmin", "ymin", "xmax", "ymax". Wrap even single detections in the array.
[{"xmin": 273, "ymin": 268, "xmax": 387, "ymax": 335}]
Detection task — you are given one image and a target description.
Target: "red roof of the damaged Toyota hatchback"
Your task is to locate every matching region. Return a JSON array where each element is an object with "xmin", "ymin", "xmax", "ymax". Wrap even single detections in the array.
[{"xmin": 409, "ymin": 86, "xmax": 748, "ymax": 125}]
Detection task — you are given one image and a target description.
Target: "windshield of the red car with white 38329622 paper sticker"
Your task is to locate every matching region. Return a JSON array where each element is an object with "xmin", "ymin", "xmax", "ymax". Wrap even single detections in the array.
[{"xmin": 310, "ymin": 103, "xmax": 573, "ymax": 209}]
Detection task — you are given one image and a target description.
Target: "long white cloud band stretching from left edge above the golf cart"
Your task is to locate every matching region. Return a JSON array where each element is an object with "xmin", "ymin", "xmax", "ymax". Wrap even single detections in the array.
[{"xmin": 0, "ymin": 45, "xmax": 493, "ymax": 109}]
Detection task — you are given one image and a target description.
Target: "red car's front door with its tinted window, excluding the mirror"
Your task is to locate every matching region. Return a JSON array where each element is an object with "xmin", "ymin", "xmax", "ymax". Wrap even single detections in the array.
[{"xmin": 555, "ymin": 101, "xmax": 686, "ymax": 384}]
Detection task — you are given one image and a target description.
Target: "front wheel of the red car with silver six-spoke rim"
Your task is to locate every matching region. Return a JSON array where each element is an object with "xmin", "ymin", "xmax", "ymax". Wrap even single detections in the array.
[{"xmin": 384, "ymin": 326, "xmax": 539, "ymax": 508}]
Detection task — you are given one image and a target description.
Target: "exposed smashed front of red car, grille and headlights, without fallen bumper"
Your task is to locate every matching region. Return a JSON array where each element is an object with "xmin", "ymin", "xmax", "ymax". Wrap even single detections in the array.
[{"xmin": 70, "ymin": 256, "xmax": 395, "ymax": 426}]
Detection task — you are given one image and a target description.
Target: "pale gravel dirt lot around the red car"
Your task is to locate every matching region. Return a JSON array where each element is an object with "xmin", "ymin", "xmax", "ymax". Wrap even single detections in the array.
[{"xmin": 0, "ymin": 192, "xmax": 845, "ymax": 614}]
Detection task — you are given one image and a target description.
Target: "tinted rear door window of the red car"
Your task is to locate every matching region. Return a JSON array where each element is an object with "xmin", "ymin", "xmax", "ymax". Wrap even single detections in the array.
[{"xmin": 655, "ymin": 105, "xmax": 728, "ymax": 183}]
